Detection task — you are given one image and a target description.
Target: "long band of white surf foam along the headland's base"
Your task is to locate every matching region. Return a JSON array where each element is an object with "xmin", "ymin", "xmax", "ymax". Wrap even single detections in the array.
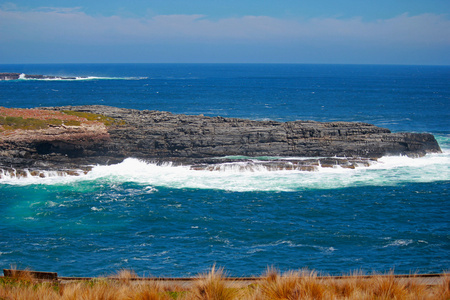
[{"xmin": 0, "ymin": 151, "xmax": 450, "ymax": 192}]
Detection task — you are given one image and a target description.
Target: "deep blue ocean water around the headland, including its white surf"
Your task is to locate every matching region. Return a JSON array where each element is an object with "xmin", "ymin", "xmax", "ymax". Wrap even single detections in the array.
[{"xmin": 0, "ymin": 64, "xmax": 450, "ymax": 277}]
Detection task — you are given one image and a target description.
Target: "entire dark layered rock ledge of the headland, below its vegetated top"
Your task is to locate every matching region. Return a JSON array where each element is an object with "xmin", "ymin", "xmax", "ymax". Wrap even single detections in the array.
[{"xmin": 0, "ymin": 105, "xmax": 441, "ymax": 177}]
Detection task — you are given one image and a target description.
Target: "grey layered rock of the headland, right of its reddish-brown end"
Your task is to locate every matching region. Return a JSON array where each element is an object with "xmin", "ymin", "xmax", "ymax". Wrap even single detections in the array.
[{"xmin": 51, "ymin": 106, "xmax": 440, "ymax": 160}]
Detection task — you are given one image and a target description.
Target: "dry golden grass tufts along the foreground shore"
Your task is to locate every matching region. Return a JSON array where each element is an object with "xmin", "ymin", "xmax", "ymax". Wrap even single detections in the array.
[{"xmin": 0, "ymin": 266, "xmax": 450, "ymax": 300}]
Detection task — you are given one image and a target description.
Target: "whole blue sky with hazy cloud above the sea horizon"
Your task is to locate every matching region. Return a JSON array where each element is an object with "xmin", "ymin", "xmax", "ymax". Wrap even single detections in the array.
[{"xmin": 0, "ymin": 0, "xmax": 450, "ymax": 65}]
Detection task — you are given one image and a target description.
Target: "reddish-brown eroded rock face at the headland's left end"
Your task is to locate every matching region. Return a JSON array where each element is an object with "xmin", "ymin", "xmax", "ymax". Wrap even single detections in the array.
[{"xmin": 0, "ymin": 123, "xmax": 110, "ymax": 170}]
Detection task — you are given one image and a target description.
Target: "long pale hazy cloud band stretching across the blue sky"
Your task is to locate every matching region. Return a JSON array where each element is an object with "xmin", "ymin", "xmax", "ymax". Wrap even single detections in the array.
[{"xmin": 0, "ymin": 7, "xmax": 450, "ymax": 44}]
